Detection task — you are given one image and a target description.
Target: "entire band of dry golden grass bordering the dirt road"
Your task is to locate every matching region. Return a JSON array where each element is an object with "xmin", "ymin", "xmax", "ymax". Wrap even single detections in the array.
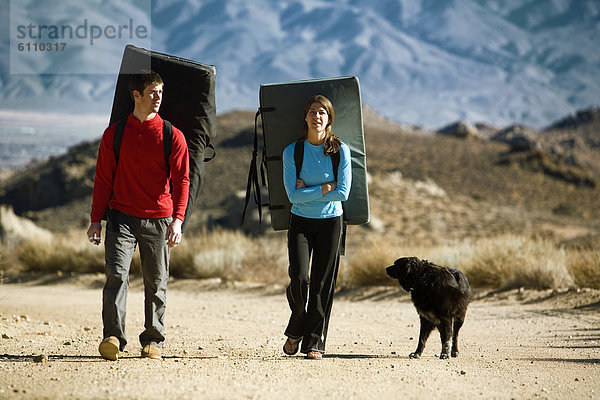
[{"xmin": 0, "ymin": 230, "xmax": 600, "ymax": 289}]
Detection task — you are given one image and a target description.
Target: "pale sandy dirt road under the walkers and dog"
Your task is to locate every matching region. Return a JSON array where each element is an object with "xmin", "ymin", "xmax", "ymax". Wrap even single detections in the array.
[{"xmin": 0, "ymin": 276, "xmax": 600, "ymax": 400}]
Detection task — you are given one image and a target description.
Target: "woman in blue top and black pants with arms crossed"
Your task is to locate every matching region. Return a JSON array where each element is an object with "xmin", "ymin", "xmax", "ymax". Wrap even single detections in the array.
[{"xmin": 283, "ymin": 95, "xmax": 352, "ymax": 359}]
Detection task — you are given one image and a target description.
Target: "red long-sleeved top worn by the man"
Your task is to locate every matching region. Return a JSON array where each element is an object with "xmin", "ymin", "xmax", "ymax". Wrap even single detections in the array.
[{"xmin": 91, "ymin": 114, "xmax": 190, "ymax": 222}]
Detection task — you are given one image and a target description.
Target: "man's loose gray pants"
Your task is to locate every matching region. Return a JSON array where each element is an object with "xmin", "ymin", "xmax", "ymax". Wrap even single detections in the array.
[{"xmin": 102, "ymin": 210, "xmax": 172, "ymax": 350}]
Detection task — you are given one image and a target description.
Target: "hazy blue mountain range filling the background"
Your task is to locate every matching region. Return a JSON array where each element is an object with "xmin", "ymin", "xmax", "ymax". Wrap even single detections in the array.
[{"xmin": 0, "ymin": 0, "xmax": 600, "ymax": 133}]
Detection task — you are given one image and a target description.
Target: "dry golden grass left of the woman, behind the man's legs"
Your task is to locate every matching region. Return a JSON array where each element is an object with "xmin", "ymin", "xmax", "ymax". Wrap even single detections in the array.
[{"xmin": 0, "ymin": 230, "xmax": 287, "ymax": 283}]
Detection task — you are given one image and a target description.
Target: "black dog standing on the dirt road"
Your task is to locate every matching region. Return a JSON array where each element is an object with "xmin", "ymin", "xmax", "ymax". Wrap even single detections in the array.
[{"xmin": 386, "ymin": 257, "xmax": 471, "ymax": 359}]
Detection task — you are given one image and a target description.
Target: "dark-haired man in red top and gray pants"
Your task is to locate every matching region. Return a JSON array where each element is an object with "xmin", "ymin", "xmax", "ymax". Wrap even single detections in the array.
[{"xmin": 87, "ymin": 70, "xmax": 189, "ymax": 361}]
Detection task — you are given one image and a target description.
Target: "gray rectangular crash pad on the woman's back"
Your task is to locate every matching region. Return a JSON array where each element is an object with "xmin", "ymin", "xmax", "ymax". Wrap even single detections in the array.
[{"xmin": 260, "ymin": 77, "xmax": 369, "ymax": 230}]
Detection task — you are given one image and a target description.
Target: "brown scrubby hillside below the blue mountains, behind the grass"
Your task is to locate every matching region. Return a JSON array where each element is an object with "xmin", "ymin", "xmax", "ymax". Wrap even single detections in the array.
[{"xmin": 0, "ymin": 110, "xmax": 600, "ymax": 247}]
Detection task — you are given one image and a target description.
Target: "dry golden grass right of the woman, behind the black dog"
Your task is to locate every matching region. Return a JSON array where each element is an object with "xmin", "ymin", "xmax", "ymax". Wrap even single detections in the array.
[{"xmin": 340, "ymin": 235, "xmax": 600, "ymax": 289}]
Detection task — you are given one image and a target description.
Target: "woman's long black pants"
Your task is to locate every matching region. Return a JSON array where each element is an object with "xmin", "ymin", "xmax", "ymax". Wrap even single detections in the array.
[{"xmin": 285, "ymin": 214, "xmax": 342, "ymax": 353}]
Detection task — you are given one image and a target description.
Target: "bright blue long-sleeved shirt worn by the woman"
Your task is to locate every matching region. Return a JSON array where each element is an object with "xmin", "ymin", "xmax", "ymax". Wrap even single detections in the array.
[{"xmin": 283, "ymin": 141, "xmax": 352, "ymax": 218}]
